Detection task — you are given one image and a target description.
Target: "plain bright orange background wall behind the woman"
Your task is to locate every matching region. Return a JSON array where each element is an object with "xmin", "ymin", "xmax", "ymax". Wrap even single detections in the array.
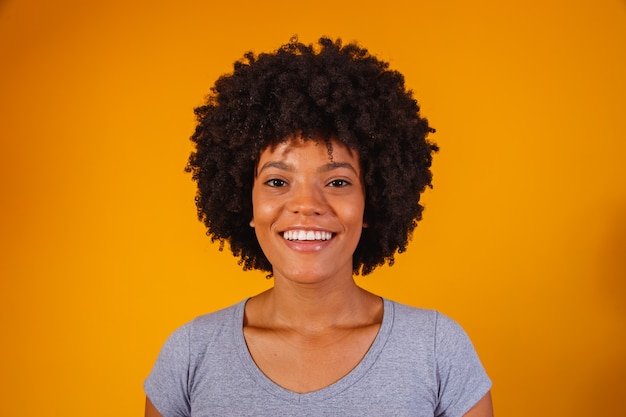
[{"xmin": 0, "ymin": 0, "xmax": 626, "ymax": 417}]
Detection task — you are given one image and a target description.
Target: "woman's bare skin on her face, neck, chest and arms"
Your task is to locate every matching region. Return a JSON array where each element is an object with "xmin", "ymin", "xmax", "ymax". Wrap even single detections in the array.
[{"xmin": 145, "ymin": 137, "xmax": 493, "ymax": 417}]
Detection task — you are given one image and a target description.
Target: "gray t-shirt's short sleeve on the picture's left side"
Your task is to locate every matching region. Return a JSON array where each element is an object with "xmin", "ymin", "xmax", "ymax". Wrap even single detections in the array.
[{"xmin": 144, "ymin": 324, "xmax": 190, "ymax": 417}]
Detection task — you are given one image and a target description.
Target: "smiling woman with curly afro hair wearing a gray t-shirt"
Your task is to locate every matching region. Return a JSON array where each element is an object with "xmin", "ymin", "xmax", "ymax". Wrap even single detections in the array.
[{"xmin": 145, "ymin": 38, "xmax": 493, "ymax": 417}]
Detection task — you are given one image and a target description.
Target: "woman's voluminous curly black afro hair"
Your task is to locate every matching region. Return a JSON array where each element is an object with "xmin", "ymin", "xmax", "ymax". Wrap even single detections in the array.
[{"xmin": 186, "ymin": 37, "xmax": 438, "ymax": 275}]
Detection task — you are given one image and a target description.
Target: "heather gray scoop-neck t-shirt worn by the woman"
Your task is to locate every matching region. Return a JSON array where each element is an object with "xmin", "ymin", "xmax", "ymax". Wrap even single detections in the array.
[{"xmin": 144, "ymin": 299, "xmax": 491, "ymax": 417}]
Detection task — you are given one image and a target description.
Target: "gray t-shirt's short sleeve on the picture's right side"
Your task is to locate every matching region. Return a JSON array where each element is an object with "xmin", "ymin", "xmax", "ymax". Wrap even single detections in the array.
[{"xmin": 435, "ymin": 313, "xmax": 491, "ymax": 417}]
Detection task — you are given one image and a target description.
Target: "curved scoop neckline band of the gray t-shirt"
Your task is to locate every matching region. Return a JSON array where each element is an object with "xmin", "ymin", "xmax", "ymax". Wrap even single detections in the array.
[{"xmin": 232, "ymin": 298, "xmax": 394, "ymax": 404}]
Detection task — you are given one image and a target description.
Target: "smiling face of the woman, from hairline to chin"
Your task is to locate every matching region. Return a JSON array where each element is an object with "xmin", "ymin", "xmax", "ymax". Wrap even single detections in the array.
[{"xmin": 250, "ymin": 137, "xmax": 365, "ymax": 283}]
